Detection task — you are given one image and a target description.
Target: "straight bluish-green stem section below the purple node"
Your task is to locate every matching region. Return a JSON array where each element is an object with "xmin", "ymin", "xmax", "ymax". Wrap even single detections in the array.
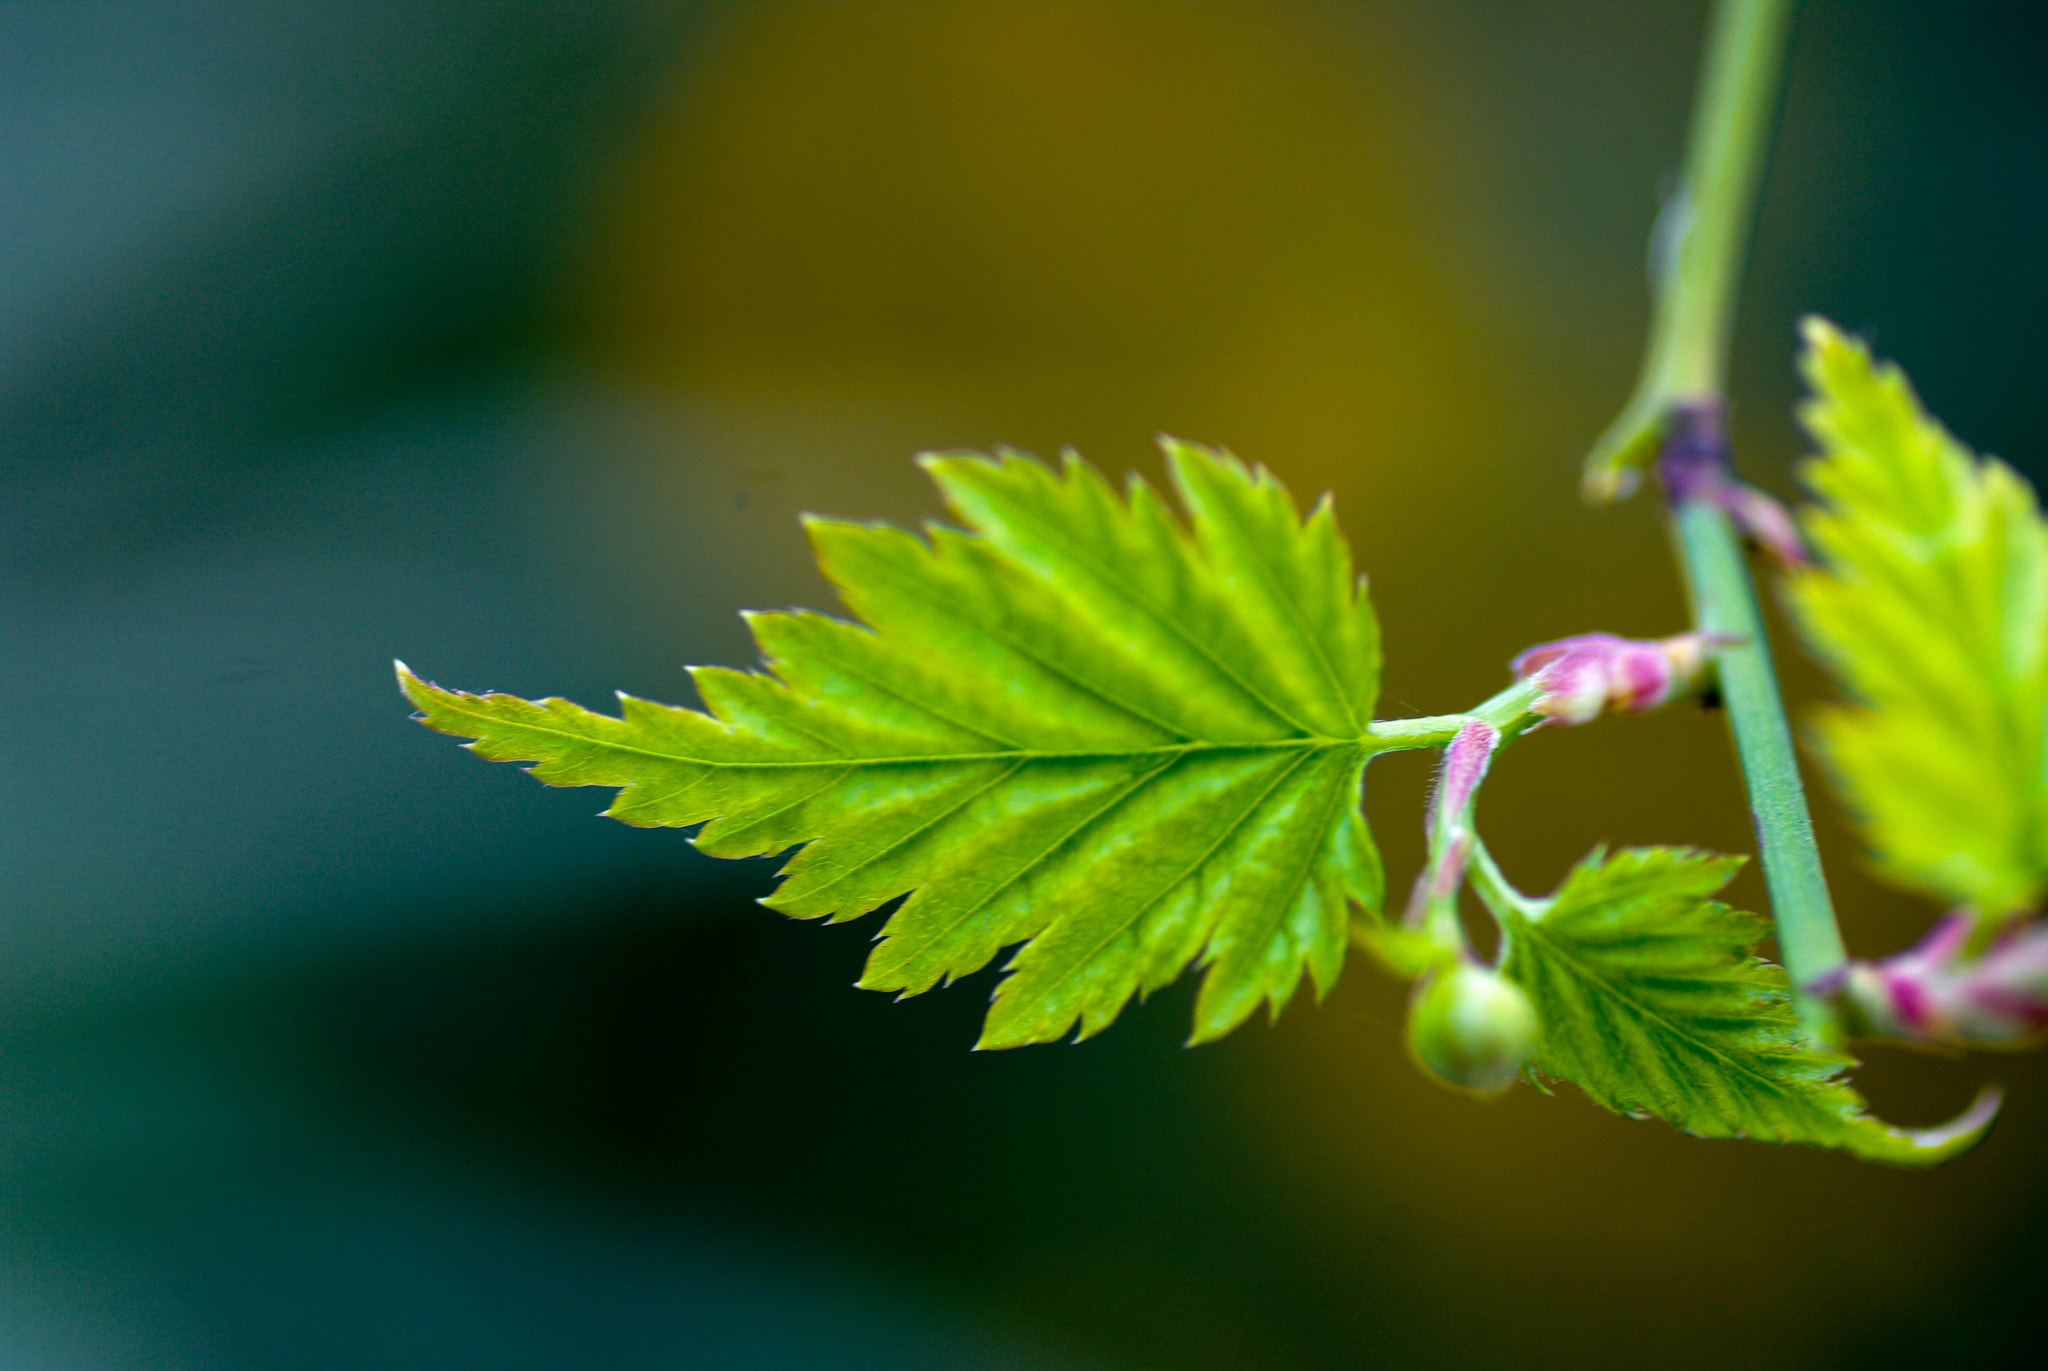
[{"xmin": 1673, "ymin": 500, "xmax": 1847, "ymax": 1041}]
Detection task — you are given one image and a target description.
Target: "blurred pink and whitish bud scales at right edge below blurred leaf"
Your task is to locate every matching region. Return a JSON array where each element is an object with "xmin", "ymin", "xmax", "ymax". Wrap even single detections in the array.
[{"xmin": 1815, "ymin": 910, "xmax": 2048, "ymax": 1047}]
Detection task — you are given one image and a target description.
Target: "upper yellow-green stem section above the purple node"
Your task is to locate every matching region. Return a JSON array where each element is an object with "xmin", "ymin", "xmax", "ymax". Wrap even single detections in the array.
[{"xmin": 1585, "ymin": 0, "xmax": 1792, "ymax": 500}]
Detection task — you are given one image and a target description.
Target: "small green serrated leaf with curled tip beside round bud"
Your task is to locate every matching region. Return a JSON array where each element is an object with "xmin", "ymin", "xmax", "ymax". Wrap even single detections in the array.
[{"xmin": 1503, "ymin": 848, "xmax": 1995, "ymax": 1166}]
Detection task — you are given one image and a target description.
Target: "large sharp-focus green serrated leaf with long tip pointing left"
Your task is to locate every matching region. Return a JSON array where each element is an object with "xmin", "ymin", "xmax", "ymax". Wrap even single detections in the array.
[{"xmin": 399, "ymin": 441, "xmax": 1384, "ymax": 1047}]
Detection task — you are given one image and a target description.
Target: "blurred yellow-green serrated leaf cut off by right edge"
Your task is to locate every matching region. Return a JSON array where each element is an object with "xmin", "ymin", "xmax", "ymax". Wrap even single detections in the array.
[{"xmin": 1786, "ymin": 320, "xmax": 2048, "ymax": 914}]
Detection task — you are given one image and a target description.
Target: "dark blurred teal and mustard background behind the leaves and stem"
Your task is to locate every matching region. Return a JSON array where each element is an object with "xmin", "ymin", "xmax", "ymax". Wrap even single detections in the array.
[{"xmin": 0, "ymin": 0, "xmax": 2048, "ymax": 1371}]
